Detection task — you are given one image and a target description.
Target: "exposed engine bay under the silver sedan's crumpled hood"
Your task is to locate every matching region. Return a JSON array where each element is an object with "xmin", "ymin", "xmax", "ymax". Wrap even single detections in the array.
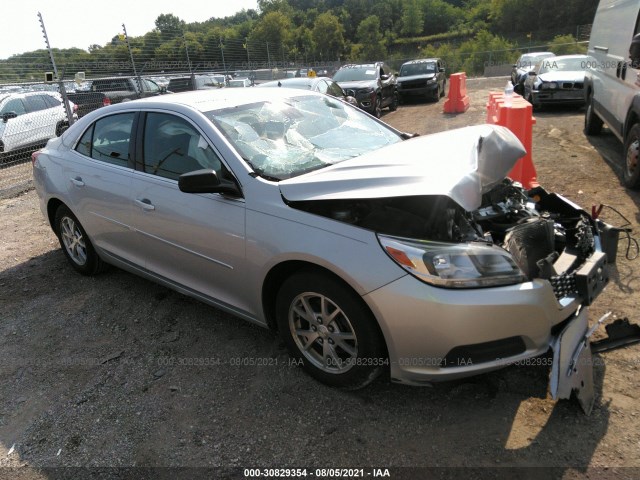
[{"xmin": 289, "ymin": 179, "xmax": 617, "ymax": 304}]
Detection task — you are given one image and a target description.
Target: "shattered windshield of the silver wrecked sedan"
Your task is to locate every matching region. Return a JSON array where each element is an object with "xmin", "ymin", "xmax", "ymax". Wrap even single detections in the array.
[{"xmin": 205, "ymin": 95, "xmax": 402, "ymax": 180}]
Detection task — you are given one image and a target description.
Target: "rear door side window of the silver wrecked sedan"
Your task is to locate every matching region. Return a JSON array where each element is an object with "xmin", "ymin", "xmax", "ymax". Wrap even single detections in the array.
[{"xmin": 76, "ymin": 113, "xmax": 135, "ymax": 167}]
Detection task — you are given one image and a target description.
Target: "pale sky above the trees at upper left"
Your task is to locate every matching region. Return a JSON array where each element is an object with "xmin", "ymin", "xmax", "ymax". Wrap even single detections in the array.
[{"xmin": 0, "ymin": 0, "xmax": 258, "ymax": 59}]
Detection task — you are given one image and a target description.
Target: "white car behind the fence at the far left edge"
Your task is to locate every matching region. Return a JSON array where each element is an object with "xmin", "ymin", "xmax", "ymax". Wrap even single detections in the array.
[{"xmin": 0, "ymin": 91, "xmax": 76, "ymax": 161}]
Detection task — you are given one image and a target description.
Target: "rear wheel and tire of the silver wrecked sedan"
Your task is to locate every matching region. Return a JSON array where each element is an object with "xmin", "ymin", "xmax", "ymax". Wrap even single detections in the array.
[{"xmin": 54, "ymin": 205, "xmax": 106, "ymax": 275}]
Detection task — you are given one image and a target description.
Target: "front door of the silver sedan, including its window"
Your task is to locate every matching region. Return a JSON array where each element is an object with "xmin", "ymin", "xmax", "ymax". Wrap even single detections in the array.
[{"xmin": 131, "ymin": 111, "xmax": 247, "ymax": 309}]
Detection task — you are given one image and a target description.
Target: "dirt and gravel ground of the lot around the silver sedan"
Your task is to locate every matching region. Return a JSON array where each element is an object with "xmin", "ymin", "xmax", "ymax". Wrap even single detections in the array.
[{"xmin": 0, "ymin": 79, "xmax": 640, "ymax": 479}]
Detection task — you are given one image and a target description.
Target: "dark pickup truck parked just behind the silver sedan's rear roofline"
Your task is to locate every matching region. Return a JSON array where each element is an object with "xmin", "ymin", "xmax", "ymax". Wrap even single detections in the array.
[{"xmin": 67, "ymin": 77, "xmax": 167, "ymax": 117}]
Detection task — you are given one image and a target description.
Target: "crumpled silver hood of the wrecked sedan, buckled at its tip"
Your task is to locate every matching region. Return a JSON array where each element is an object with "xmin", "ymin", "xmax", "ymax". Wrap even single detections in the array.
[{"xmin": 279, "ymin": 125, "xmax": 526, "ymax": 211}]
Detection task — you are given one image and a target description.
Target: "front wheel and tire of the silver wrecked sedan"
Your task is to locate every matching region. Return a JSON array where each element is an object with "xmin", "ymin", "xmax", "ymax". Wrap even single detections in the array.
[{"xmin": 276, "ymin": 272, "xmax": 388, "ymax": 390}]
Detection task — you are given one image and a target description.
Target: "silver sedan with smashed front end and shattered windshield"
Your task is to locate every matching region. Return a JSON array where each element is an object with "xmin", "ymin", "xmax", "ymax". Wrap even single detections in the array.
[{"xmin": 33, "ymin": 88, "xmax": 615, "ymax": 402}]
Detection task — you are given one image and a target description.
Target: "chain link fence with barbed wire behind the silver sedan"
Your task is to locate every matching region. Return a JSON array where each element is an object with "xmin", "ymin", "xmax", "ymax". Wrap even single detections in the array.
[{"xmin": 0, "ymin": 17, "xmax": 589, "ymax": 198}]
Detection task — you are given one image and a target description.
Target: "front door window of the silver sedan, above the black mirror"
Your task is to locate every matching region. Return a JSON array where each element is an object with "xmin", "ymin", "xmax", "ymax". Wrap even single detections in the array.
[{"xmin": 143, "ymin": 113, "xmax": 222, "ymax": 180}]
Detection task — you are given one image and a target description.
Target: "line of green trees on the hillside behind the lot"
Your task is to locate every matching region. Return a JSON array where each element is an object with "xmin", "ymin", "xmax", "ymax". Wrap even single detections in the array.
[{"xmin": 0, "ymin": 0, "xmax": 597, "ymax": 79}]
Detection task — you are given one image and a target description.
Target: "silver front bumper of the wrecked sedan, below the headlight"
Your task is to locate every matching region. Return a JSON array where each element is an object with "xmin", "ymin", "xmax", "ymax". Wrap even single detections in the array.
[{"xmin": 364, "ymin": 275, "xmax": 596, "ymax": 385}]
